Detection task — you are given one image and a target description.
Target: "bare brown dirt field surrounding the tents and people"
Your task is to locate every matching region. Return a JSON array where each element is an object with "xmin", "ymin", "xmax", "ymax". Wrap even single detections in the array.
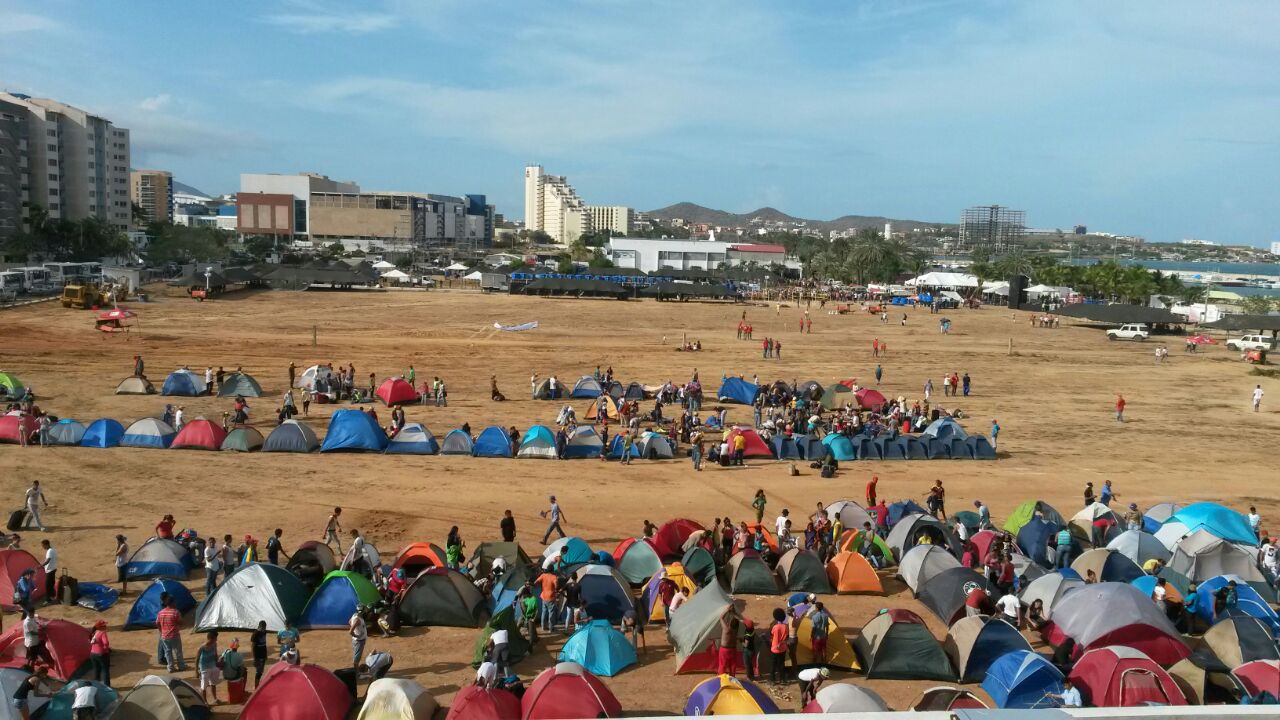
[{"xmin": 0, "ymin": 286, "xmax": 1280, "ymax": 716}]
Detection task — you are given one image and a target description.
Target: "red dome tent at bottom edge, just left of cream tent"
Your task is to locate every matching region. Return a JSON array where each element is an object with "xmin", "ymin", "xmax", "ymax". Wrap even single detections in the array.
[{"xmin": 240, "ymin": 661, "xmax": 351, "ymax": 720}]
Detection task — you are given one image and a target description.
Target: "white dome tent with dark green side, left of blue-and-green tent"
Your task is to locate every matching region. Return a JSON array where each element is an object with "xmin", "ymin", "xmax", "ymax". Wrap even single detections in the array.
[{"xmin": 195, "ymin": 562, "xmax": 310, "ymax": 627}]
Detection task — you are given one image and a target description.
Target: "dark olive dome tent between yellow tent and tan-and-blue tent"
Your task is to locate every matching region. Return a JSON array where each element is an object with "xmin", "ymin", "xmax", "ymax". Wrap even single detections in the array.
[{"xmin": 854, "ymin": 610, "xmax": 956, "ymax": 680}]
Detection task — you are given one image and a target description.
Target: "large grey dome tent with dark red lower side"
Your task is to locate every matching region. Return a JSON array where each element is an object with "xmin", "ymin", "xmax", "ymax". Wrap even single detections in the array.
[{"xmin": 1053, "ymin": 583, "xmax": 1190, "ymax": 665}]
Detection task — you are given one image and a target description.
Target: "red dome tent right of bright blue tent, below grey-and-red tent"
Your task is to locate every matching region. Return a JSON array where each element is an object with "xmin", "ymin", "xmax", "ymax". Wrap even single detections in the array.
[{"xmin": 1070, "ymin": 646, "xmax": 1187, "ymax": 707}]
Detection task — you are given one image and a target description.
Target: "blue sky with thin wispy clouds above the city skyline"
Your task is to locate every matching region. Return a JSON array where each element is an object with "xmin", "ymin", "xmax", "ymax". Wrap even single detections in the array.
[{"xmin": 0, "ymin": 0, "xmax": 1280, "ymax": 245}]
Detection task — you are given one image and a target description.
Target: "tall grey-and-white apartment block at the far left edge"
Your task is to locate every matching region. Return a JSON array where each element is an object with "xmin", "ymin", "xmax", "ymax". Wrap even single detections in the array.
[{"xmin": 0, "ymin": 92, "xmax": 131, "ymax": 234}]
